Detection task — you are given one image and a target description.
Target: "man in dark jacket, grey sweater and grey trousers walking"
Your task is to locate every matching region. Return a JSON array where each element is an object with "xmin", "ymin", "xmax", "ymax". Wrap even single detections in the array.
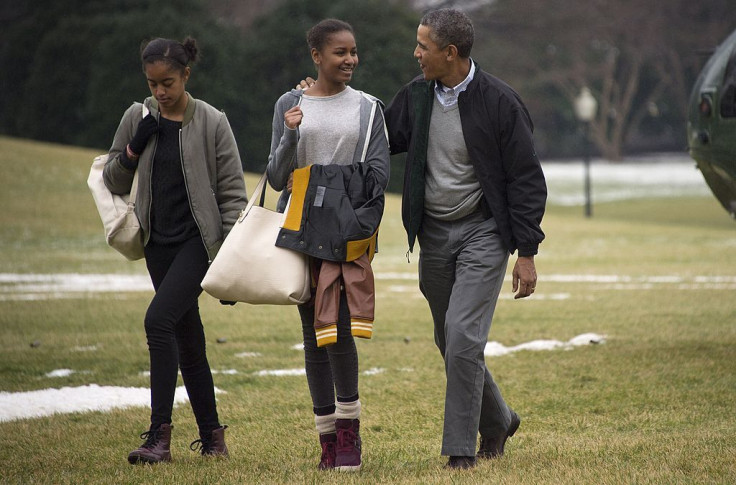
[{"xmin": 385, "ymin": 9, "xmax": 547, "ymax": 468}]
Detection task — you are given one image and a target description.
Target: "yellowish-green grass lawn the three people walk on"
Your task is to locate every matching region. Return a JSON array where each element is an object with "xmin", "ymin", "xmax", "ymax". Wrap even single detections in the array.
[{"xmin": 0, "ymin": 137, "xmax": 736, "ymax": 484}]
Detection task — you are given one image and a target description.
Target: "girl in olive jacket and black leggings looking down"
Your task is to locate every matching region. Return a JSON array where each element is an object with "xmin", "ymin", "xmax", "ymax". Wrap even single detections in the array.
[{"xmin": 103, "ymin": 38, "xmax": 247, "ymax": 464}]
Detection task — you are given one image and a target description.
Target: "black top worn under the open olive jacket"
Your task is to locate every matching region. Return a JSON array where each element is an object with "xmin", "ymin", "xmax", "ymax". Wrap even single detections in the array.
[{"xmin": 151, "ymin": 116, "xmax": 199, "ymax": 244}]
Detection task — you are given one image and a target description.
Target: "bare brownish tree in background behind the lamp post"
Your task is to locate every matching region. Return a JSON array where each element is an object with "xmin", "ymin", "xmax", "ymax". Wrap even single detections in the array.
[{"xmin": 476, "ymin": 0, "xmax": 736, "ymax": 160}]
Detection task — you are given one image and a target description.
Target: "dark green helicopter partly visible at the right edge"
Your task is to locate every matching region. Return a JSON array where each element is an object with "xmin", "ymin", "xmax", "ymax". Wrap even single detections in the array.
[{"xmin": 687, "ymin": 30, "xmax": 736, "ymax": 218}]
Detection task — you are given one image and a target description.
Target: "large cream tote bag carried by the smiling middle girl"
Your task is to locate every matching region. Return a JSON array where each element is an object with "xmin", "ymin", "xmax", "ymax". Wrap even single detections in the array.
[{"xmin": 202, "ymin": 174, "xmax": 311, "ymax": 305}]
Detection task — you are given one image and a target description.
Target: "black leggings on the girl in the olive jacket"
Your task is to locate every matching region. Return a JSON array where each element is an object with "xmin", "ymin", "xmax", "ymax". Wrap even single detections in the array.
[{"xmin": 145, "ymin": 236, "xmax": 220, "ymax": 434}]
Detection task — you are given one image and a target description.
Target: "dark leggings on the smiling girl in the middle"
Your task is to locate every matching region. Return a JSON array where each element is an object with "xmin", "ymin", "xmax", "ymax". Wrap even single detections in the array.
[{"xmin": 299, "ymin": 291, "xmax": 358, "ymax": 415}]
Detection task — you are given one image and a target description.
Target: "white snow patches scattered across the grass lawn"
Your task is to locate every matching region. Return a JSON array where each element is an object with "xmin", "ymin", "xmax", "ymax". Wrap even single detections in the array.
[{"xmin": 0, "ymin": 154, "xmax": 716, "ymax": 421}]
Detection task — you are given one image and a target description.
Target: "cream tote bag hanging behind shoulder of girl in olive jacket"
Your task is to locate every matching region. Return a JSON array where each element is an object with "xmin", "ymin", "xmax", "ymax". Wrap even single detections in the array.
[{"xmin": 87, "ymin": 105, "xmax": 148, "ymax": 261}]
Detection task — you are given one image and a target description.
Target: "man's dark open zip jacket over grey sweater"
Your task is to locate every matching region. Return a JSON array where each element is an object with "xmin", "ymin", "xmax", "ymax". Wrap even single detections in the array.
[{"xmin": 384, "ymin": 64, "xmax": 547, "ymax": 256}]
